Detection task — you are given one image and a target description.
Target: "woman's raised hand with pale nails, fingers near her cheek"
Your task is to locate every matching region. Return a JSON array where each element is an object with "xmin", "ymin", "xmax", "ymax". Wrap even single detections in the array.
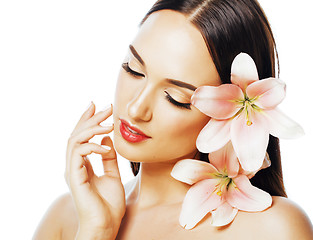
[{"xmin": 65, "ymin": 103, "xmax": 126, "ymax": 239}]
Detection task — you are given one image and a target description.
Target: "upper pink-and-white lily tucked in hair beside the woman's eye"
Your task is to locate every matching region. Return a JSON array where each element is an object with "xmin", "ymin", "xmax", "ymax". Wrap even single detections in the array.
[{"xmin": 191, "ymin": 53, "xmax": 304, "ymax": 171}]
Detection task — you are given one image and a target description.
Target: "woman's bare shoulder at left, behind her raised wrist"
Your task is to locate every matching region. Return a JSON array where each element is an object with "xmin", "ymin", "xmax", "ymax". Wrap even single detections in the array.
[{"xmin": 33, "ymin": 193, "xmax": 78, "ymax": 240}]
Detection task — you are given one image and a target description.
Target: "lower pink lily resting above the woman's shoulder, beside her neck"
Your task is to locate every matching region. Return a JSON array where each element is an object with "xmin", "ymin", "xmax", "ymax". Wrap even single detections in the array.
[{"xmin": 171, "ymin": 142, "xmax": 272, "ymax": 229}]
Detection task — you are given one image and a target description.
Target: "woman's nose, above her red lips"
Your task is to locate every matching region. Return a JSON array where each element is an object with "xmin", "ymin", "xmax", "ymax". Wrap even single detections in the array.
[{"xmin": 127, "ymin": 85, "xmax": 153, "ymax": 122}]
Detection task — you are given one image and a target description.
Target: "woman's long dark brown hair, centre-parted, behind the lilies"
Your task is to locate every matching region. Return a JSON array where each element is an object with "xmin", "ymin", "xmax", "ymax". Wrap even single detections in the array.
[{"xmin": 131, "ymin": 0, "xmax": 287, "ymax": 197}]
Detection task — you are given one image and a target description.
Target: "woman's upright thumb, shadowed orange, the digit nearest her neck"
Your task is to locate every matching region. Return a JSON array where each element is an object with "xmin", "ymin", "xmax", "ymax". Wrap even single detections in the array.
[{"xmin": 101, "ymin": 136, "xmax": 121, "ymax": 178}]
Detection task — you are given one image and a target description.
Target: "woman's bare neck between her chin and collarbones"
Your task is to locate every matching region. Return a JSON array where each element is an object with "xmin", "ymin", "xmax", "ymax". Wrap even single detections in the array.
[{"xmin": 128, "ymin": 162, "xmax": 190, "ymax": 209}]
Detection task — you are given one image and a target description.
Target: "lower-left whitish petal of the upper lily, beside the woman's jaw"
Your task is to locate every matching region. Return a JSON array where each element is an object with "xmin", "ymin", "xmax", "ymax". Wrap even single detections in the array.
[{"xmin": 196, "ymin": 118, "xmax": 231, "ymax": 153}]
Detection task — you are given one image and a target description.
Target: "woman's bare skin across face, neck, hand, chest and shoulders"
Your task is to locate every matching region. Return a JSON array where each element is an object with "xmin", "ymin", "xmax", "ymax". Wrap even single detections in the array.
[{"xmin": 34, "ymin": 10, "xmax": 313, "ymax": 240}]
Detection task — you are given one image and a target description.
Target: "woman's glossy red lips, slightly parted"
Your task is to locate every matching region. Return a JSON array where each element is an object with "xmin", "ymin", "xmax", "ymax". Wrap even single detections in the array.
[{"xmin": 120, "ymin": 119, "xmax": 151, "ymax": 143}]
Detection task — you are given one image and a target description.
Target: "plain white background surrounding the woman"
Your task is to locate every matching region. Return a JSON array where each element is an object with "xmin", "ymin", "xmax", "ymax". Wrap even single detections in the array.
[{"xmin": 0, "ymin": 0, "xmax": 313, "ymax": 239}]
